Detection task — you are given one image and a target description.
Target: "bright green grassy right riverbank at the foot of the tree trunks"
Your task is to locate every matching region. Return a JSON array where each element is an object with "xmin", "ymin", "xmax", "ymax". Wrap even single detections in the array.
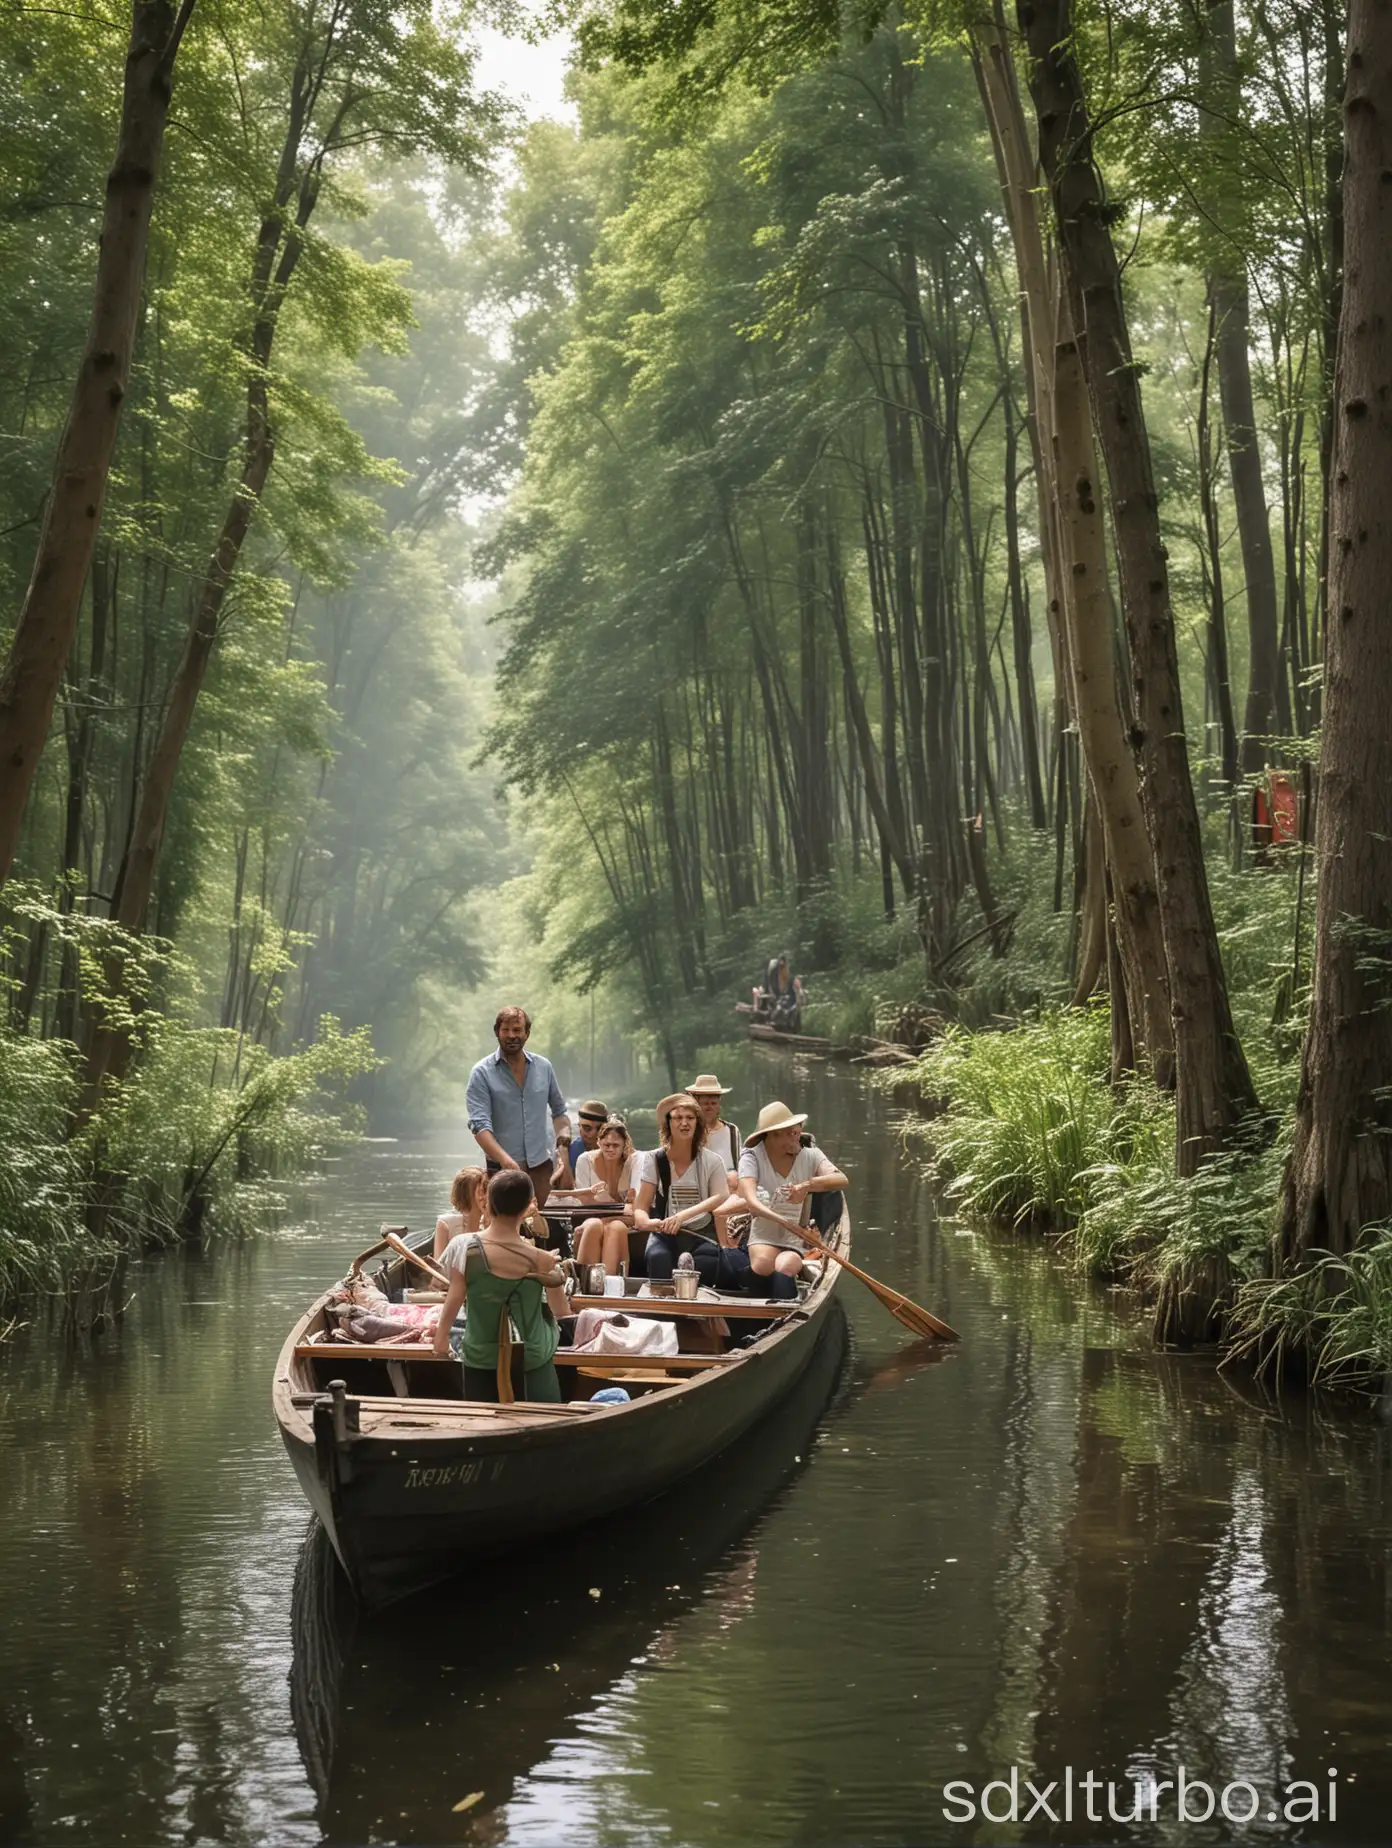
[{"xmin": 869, "ymin": 1000, "xmax": 1392, "ymax": 1395}]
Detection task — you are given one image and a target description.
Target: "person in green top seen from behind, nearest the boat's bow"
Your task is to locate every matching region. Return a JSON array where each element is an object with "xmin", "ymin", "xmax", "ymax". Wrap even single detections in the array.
[{"xmin": 434, "ymin": 1166, "xmax": 569, "ymax": 1404}]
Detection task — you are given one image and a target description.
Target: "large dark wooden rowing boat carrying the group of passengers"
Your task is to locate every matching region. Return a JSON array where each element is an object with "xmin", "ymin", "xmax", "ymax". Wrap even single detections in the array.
[{"xmin": 274, "ymin": 1212, "xmax": 850, "ymax": 1608}]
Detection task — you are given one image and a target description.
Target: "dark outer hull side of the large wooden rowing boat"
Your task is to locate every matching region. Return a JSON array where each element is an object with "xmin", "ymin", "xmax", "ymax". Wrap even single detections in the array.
[{"xmin": 281, "ymin": 1279, "xmax": 839, "ymax": 1610}]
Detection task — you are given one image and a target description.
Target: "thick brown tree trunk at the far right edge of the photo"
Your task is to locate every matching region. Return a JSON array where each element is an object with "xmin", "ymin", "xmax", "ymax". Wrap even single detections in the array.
[{"xmin": 1281, "ymin": 0, "xmax": 1392, "ymax": 1264}]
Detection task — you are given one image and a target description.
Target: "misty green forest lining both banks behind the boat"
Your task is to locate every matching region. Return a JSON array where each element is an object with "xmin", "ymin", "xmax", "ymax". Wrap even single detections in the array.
[{"xmin": 0, "ymin": 0, "xmax": 1392, "ymax": 1379}]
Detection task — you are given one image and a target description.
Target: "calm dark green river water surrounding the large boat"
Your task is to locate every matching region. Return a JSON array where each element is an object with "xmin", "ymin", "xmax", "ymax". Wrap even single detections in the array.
[{"xmin": 0, "ymin": 1063, "xmax": 1392, "ymax": 1848}]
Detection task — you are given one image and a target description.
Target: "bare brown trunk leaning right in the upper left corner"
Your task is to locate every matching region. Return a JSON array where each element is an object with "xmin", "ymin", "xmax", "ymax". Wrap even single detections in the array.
[{"xmin": 0, "ymin": 0, "xmax": 194, "ymax": 883}]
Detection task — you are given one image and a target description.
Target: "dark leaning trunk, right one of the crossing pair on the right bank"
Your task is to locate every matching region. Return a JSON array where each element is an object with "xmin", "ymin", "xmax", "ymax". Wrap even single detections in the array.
[{"xmin": 1017, "ymin": 0, "xmax": 1257, "ymax": 1173}]
